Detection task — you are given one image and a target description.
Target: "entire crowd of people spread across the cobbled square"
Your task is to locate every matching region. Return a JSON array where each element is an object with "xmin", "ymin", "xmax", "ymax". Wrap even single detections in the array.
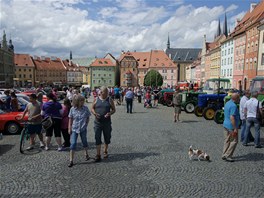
[{"xmin": 1, "ymin": 83, "xmax": 262, "ymax": 167}]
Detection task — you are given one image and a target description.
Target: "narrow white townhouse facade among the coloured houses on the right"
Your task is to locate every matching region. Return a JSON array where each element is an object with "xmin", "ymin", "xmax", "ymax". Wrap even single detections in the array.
[{"xmin": 220, "ymin": 37, "xmax": 234, "ymax": 87}]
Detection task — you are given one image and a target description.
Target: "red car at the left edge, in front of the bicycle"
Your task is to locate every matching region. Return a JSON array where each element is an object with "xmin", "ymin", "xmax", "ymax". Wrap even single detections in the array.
[{"xmin": 0, "ymin": 110, "xmax": 28, "ymax": 134}]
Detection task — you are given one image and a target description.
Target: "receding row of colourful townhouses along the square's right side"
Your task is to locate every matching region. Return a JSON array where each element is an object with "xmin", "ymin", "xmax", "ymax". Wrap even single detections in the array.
[{"xmin": 186, "ymin": 0, "xmax": 264, "ymax": 90}]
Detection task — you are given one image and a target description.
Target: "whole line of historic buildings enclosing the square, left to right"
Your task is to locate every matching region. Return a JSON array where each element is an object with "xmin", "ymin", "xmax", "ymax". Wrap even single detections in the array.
[{"xmin": 0, "ymin": 1, "xmax": 264, "ymax": 89}]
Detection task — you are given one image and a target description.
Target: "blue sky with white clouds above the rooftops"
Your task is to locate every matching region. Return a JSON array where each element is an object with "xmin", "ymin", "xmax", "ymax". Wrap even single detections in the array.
[{"xmin": 0, "ymin": 0, "xmax": 259, "ymax": 58}]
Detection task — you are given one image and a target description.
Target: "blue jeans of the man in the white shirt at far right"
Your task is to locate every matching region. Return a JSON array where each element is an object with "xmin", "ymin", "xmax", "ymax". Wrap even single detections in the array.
[{"xmin": 243, "ymin": 118, "xmax": 260, "ymax": 146}]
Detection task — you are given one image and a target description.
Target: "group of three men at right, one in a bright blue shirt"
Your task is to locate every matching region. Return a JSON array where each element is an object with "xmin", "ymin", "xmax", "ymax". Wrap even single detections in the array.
[{"xmin": 222, "ymin": 90, "xmax": 262, "ymax": 162}]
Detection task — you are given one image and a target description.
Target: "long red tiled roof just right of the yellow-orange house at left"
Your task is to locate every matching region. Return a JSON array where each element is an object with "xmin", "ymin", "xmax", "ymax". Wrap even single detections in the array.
[{"xmin": 33, "ymin": 57, "xmax": 66, "ymax": 71}]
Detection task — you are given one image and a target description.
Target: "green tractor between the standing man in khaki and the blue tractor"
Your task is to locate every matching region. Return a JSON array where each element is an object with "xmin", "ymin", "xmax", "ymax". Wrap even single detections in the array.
[{"xmin": 181, "ymin": 91, "xmax": 206, "ymax": 113}]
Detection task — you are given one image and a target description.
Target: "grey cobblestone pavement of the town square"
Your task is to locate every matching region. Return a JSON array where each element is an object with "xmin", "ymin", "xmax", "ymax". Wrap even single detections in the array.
[{"xmin": 0, "ymin": 100, "xmax": 264, "ymax": 197}]
